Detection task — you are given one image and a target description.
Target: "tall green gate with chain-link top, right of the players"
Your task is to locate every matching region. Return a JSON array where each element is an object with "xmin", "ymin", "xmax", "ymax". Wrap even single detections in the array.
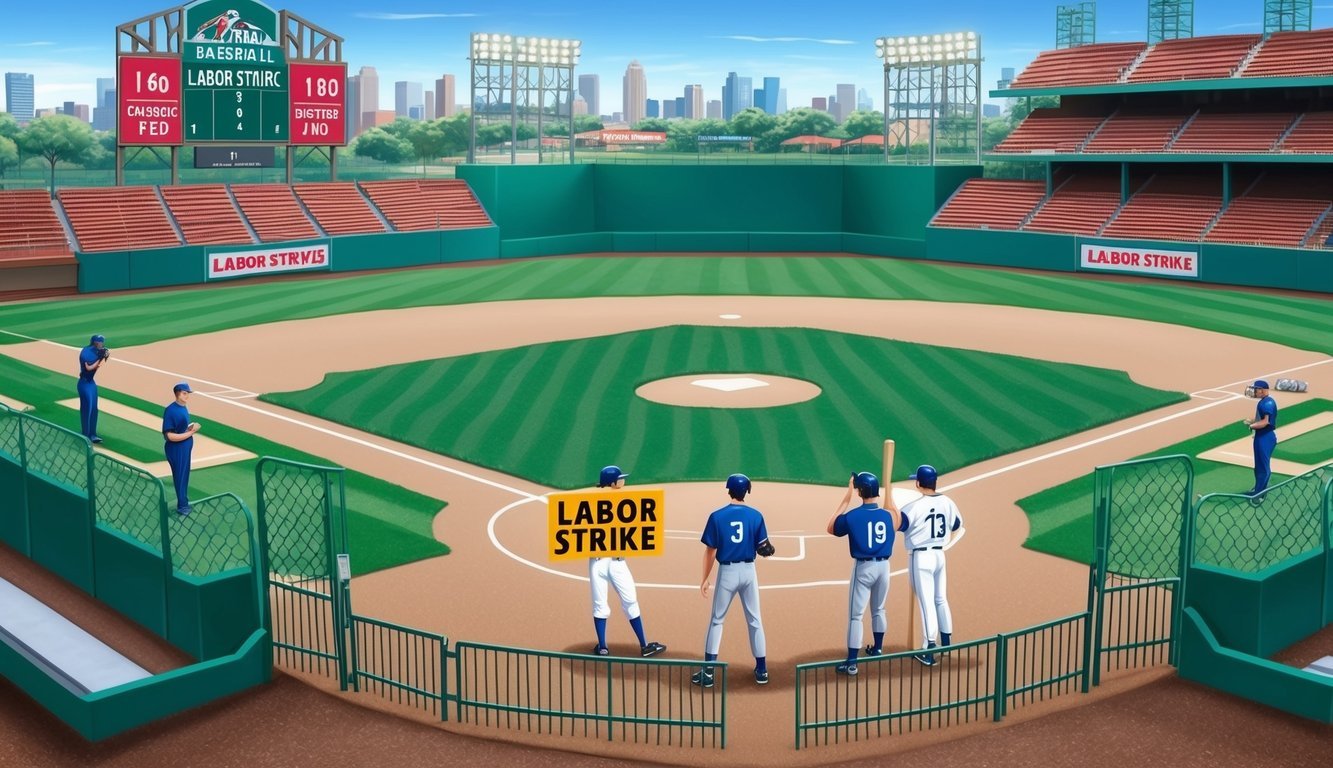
[{"xmin": 1085, "ymin": 455, "xmax": 1194, "ymax": 684}]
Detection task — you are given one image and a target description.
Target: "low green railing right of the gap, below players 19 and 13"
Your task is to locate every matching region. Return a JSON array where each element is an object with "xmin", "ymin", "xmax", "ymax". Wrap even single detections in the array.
[{"xmin": 796, "ymin": 613, "xmax": 1089, "ymax": 749}]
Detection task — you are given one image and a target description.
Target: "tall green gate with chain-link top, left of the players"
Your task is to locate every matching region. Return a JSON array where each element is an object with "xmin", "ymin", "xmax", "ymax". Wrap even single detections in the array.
[{"xmin": 255, "ymin": 457, "xmax": 355, "ymax": 691}]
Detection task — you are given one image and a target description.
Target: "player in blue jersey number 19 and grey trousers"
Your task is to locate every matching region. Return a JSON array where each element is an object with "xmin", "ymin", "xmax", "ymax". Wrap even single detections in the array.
[{"xmin": 828, "ymin": 472, "xmax": 897, "ymax": 675}]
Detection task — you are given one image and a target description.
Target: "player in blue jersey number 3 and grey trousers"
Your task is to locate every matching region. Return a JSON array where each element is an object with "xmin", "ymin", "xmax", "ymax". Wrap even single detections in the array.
[{"xmin": 690, "ymin": 475, "xmax": 773, "ymax": 688}]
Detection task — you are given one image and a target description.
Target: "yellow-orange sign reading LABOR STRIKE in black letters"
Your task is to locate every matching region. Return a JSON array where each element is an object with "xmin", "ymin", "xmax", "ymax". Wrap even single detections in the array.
[{"xmin": 547, "ymin": 489, "xmax": 667, "ymax": 560}]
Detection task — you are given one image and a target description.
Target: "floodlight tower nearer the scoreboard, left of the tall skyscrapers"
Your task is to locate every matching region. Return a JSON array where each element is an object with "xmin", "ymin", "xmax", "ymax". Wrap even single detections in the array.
[{"xmin": 468, "ymin": 32, "xmax": 583, "ymax": 164}]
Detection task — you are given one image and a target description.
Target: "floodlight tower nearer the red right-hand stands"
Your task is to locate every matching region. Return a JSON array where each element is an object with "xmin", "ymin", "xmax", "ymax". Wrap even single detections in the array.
[{"xmin": 874, "ymin": 32, "xmax": 981, "ymax": 165}]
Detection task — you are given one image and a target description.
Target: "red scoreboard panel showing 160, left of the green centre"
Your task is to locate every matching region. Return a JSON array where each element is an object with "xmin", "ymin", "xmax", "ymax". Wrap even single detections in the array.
[{"xmin": 116, "ymin": 56, "xmax": 185, "ymax": 147}]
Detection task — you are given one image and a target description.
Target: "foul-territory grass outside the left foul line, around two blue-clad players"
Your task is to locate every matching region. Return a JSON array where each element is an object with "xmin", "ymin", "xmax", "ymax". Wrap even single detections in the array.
[{"xmin": 0, "ymin": 356, "xmax": 449, "ymax": 575}]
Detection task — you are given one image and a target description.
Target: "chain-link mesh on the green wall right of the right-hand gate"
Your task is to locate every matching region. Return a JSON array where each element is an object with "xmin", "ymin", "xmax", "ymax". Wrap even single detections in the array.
[{"xmin": 1193, "ymin": 467, "xmax": 1333, "ymax": 573}]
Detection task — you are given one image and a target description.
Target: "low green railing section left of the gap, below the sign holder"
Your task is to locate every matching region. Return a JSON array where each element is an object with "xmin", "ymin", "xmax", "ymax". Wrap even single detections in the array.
[{"xmin": 451, "ymin": 643, "xmax": 728, "ymax": 748}]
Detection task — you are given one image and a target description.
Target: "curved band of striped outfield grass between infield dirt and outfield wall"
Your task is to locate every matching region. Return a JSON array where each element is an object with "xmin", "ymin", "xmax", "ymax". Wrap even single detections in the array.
[{"xmin": 0, "ymin": 256, "xmax": 1333, "ymax": 353}]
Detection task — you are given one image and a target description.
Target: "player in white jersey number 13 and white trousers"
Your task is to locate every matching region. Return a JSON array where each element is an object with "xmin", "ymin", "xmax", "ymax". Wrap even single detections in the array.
[{"xmin": 898, "ymin": 464, "xmax": 962, "ymax": 667}]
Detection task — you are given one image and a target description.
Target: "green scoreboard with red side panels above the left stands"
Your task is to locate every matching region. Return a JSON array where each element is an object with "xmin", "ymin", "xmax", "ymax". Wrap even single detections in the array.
[{"xmin": 117, "ymin": 0, "xmax": 347, "ymax": 147}]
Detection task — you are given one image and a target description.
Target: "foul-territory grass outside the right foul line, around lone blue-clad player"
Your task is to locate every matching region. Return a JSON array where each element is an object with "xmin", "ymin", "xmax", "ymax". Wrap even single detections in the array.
[{"xmin": 1018, "ymin": 400, "xmax": 1333, "ymax": 563}]
